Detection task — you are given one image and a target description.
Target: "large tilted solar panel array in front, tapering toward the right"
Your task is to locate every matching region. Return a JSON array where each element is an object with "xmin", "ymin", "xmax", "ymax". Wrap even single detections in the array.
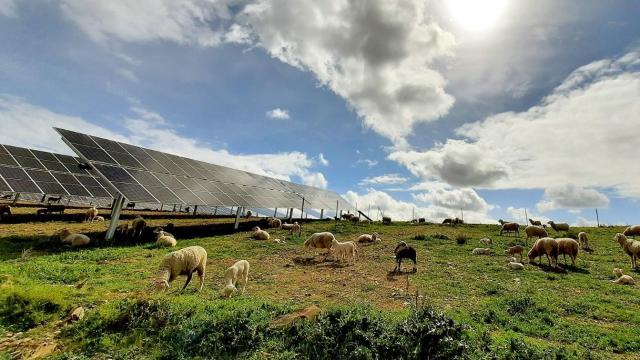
[{"xmin": 56, "ymin": 128, "xmax": 351, "ymax": 209}]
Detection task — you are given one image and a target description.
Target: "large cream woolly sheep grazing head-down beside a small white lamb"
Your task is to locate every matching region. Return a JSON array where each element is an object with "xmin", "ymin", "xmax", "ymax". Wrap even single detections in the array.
[{"xmin": 154, "ymin": 246, "xmax": 207, "ymax": 291}]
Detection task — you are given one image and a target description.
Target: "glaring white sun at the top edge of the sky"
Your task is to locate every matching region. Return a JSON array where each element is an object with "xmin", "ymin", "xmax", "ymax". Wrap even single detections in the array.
[{"xmin": 447, "ymin": 0, "xmax": 506, "ymax": 31}]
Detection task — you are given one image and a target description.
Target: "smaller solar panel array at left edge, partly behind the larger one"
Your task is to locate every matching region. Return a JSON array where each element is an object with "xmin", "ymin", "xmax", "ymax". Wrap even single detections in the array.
[{"xmin": 0, "ymin": 145, "xmax": 113, "ymax": 198}]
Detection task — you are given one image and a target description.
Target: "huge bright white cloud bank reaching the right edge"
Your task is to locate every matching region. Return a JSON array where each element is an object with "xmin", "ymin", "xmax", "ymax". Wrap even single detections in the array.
[{"xmin": 389, "ymin": 50, "xmax": 640, "ymax": 200}]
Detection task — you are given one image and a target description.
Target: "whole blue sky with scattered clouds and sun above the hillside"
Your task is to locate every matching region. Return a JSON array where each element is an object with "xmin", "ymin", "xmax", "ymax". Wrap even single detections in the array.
[{"xmin": 0, "ymin": 0, "xmax": 640, "ymax": 225}]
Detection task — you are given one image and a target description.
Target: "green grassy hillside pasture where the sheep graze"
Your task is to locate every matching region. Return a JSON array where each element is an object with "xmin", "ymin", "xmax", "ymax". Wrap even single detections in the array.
[{"xmin": 0, "ymin": 222, "xmax": 640, "ymax": 359}]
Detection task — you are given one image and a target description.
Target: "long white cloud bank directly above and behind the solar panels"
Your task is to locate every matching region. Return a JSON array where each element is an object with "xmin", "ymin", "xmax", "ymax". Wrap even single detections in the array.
[{"xmin": 0, "ymin": 94, "xmax": 327, "ymax": 188}]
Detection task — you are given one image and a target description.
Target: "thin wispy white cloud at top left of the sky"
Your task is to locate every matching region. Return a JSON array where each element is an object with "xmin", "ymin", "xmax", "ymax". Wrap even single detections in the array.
[{"xmin": 59, "ymin": 0, "xmax": 231, "ymax": 46}]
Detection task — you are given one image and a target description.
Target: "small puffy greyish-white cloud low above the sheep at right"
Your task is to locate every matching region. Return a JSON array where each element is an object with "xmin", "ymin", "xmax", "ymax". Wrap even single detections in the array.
[{"xmin": 536, "ymin": 185, "xmax": 609, "ymax": 212}]
